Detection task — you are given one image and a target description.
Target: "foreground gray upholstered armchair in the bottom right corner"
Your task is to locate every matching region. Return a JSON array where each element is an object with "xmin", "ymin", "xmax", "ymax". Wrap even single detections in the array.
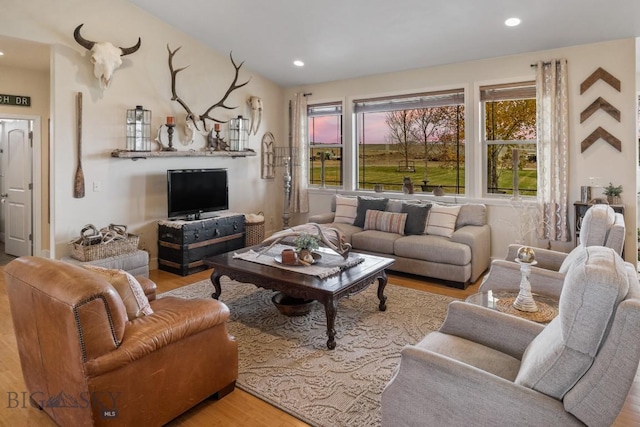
[{"xmin": 382, "ymin": 246, "xmax": 640, "ymax": 426}]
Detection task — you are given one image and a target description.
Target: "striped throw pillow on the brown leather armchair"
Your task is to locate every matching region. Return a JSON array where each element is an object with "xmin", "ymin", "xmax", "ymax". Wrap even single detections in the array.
[{"xmin": 83, "ymin": 265, "xmax": 153, "ymax": 320}]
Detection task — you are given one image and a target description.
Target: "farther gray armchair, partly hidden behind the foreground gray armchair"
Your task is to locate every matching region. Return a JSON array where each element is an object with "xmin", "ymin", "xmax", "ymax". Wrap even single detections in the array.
[{"xmin": 480, "ymin": 205, "xmax": 626, "ymax": 297}]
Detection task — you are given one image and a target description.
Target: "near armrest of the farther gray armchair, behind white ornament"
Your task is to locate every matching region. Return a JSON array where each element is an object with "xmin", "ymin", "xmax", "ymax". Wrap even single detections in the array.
[{"xmin": 479, "ymin": 259, "xmax": 565, "ymax": 298}]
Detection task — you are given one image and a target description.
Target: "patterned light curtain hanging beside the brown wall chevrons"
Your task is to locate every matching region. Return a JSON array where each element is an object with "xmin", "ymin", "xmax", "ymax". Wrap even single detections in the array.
[{"xmin": 536, "ymin": 59, "xmax": 571, "ymax": 242}]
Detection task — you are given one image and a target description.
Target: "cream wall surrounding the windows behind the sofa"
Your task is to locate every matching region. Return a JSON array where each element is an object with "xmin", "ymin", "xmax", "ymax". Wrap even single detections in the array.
[{"xmin": 285, "ymin": 39, "xmax": 638, "ymax": 262}]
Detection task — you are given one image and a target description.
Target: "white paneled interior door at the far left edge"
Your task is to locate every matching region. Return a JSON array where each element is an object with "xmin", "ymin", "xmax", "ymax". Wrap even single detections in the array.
[{"xmin": 1, "ymin": 120, "xmax": 33, "ymax": 256}]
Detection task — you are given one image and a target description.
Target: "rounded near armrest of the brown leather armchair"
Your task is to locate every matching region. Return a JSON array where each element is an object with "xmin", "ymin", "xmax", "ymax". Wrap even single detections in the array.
[{"xmin": 85, "ymin": 297, "xmax": 229, "ymax": 376}]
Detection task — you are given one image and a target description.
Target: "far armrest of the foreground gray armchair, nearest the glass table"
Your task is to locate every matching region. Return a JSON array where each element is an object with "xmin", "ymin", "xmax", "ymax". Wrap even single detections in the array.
[{"xmin": 439, "ymin": 301, "xmax": 544, "ymax": 359}]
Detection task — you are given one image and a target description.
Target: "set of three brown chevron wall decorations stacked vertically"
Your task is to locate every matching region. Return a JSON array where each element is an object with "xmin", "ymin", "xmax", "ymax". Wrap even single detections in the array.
[{"xmin": 580, "ymin": 67, "xmax": 622, "ymax": 153}]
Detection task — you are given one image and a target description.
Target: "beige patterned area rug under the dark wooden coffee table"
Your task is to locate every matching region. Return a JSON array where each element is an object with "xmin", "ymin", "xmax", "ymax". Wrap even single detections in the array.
[{"xmin": 160, "ymin": 277, "xmax": 454, "ymax": 427}]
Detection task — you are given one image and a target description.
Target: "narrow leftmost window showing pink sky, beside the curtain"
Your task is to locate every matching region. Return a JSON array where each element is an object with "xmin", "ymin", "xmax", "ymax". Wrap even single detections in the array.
[{"xmin": 307, "ymin": 102, "xmax": 342, "ymax": 188}]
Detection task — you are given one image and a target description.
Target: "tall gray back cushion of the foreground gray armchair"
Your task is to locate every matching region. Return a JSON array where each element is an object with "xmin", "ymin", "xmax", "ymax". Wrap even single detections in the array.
[{"xmin": 516, "ymin": 246, "xmax": 629, "ymax": 399}]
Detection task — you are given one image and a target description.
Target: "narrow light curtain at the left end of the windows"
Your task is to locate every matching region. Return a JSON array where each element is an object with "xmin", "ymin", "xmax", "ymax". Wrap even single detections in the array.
[{"xmin": 289, "ymin": 93, "xmax": 309, "ymax": 212}]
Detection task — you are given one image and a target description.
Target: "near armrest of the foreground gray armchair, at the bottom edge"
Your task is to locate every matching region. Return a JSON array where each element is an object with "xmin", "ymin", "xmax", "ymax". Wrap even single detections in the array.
[{"xmin": 382, "ymin": 346, "xmax": 582, "ymax": 426}]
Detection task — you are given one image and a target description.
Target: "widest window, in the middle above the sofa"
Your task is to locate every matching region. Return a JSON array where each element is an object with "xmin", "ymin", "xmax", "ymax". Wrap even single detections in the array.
[{"xmin": 354, "ymin": 89, "xmax": 465, "ymax": 194}]
